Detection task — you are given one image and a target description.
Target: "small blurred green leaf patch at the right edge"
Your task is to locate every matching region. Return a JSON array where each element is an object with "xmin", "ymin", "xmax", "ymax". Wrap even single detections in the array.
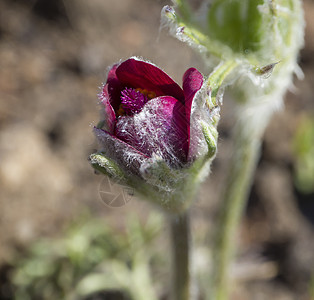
[{"xmin": 294, "ymin": 115, "xmax": 314, "ymax": 194}]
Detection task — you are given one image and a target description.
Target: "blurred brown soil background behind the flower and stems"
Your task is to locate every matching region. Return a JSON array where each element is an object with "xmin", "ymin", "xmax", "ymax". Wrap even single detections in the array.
[{"xmin": 0, "ymin": 0, "xmax": 314, "ymax": 300}]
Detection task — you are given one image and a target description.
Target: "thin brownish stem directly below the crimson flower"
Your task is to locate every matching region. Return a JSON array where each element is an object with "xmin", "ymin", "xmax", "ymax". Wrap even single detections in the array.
[{"xmin": 170, "ymin": 211, "xmax": 191, "ymax": 300}]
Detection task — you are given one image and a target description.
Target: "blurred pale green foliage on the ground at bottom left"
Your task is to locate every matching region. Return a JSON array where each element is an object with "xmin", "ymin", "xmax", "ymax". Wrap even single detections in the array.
[{"xmin": 12, "ymin": 214, "xmax": 162, "ymax": 300}]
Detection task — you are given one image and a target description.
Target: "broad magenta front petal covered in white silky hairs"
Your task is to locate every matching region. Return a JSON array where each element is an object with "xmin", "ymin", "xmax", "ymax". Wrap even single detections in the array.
[{"xmin": 115, "ymin": 96, "xmax": 188, "ymax": 166}]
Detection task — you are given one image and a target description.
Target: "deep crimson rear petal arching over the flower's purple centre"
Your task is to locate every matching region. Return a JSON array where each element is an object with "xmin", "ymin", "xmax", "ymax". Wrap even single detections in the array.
[{"xmin": 116, "ymin": 58, "xmax": 184, "ymax": 103}]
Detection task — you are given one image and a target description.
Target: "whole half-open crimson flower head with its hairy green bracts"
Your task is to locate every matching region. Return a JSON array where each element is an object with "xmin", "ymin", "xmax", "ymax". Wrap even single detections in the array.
[{"xmin": 91, "ymin": 58, "xmax": 217, "ymax": 212}]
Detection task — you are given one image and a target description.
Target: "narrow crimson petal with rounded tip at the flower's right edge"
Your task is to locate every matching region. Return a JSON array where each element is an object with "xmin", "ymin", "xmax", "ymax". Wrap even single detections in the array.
[{"xmin": 183, "ymin": 68, "xmax": 204, "ymax": 157}]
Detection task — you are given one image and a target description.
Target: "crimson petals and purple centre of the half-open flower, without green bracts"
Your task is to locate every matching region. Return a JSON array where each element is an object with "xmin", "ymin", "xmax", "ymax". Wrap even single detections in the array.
[{"xmin": 95, "ymin": 58, "xmax": 203, "ymax": 167}]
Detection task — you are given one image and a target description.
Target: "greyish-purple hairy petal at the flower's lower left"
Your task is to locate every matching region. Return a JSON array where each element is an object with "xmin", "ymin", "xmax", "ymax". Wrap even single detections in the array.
[{"xmin": 94, "ymin": 127, "xmax": 149, "ymax": 176}]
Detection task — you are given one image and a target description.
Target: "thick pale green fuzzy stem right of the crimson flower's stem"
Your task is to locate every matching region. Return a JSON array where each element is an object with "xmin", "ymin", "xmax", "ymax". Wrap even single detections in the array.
[{"xmin": 210, "ymin": 122, "xmax": 260, "ymax": 300}]
